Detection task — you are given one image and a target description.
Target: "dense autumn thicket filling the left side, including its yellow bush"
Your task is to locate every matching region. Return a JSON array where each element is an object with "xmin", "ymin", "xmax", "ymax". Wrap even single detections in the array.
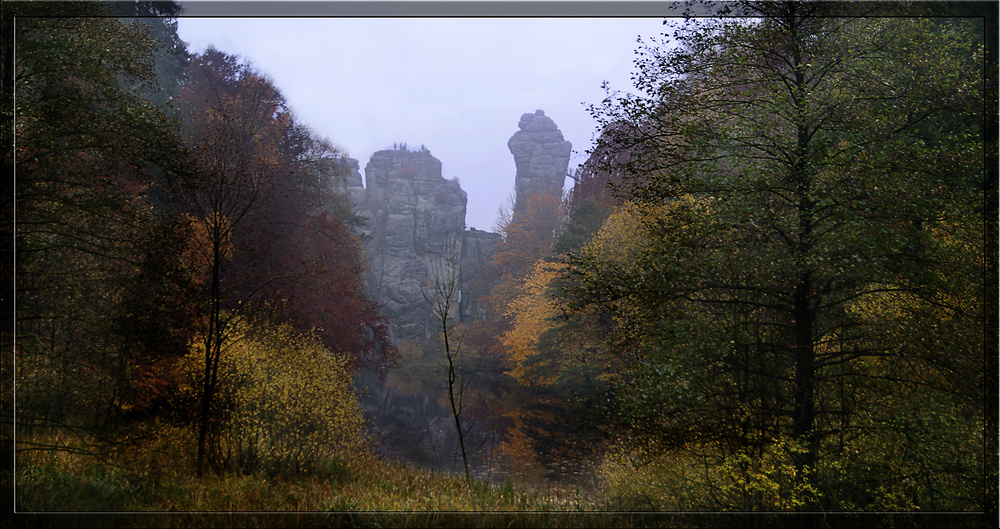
[{"xmin": 13, "ymin": 3, "xmax": 392, "ymax": 474}]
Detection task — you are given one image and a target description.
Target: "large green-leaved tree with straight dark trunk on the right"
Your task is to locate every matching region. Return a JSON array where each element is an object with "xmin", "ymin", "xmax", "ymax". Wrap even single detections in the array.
[{"xmin": 571, "ymin": 2, "xmax": 984, "ymax": 509}]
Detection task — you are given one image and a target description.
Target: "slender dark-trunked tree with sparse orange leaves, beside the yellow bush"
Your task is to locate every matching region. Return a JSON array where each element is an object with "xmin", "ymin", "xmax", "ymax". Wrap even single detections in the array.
[{"xmin": 177, "ymin": 49, "xmax": 278, "ymax": 477}]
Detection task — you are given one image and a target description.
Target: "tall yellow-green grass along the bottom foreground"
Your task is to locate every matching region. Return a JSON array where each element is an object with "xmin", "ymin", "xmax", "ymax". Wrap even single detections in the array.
[{"xmin": 15, "ymin": 428, "xmax": 632, "ymax": 527}]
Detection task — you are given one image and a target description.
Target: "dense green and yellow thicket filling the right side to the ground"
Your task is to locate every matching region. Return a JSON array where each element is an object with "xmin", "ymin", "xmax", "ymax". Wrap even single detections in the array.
[{"xmin": 567, "ymin": 3, "xmax": 995, "ymax": 510}]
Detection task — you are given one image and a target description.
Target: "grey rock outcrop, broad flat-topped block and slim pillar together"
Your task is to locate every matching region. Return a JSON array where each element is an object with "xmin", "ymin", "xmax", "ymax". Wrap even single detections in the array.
[{"xmin": 339, "ymin": 110, "xmax": 572, "ymax": 343}]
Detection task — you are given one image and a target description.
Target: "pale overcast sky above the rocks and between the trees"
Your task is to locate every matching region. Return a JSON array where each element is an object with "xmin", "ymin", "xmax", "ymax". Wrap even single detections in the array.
[{"xmin": 178, "ymin": 17, "xmax": 676, "ymax": 230}]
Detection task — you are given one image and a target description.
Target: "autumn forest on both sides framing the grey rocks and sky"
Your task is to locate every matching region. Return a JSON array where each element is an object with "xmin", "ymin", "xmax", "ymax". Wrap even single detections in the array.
[{"xmin": 0, "ymin": 2, "xmax": 1000, "ymax": 527}]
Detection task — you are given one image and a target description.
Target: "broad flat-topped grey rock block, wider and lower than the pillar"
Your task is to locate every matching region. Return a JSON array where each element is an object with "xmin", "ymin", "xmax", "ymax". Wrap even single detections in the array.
[{"xmin": 345, "ymin": 147, "xmax": 499, "ymax": 343}]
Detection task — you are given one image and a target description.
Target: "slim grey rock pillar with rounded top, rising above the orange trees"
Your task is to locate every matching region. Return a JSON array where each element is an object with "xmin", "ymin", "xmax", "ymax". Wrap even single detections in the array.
[{"xmin": 507, "ymin": 110, "xmax": 573, "ymax": 211}]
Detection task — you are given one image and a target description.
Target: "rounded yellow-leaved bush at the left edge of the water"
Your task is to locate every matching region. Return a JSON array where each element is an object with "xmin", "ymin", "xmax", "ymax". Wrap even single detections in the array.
[{"xmin": 183, "ymin": 316, "xmax": 366, "ymax": 476}]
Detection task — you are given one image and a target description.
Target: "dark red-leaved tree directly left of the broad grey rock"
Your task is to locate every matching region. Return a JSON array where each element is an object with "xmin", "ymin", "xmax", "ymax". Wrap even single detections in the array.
[{"xmin": 247, "ymin": 146, "xmax": 394, "ymax": 371}]
